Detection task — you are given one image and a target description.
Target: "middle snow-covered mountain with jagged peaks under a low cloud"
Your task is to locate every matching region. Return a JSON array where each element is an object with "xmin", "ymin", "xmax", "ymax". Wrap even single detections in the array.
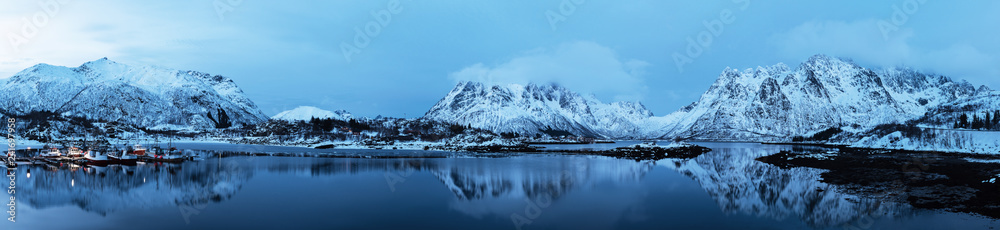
[{"xmin": 424, "ymin": 82, "xmax": 653, "ymax": 138}]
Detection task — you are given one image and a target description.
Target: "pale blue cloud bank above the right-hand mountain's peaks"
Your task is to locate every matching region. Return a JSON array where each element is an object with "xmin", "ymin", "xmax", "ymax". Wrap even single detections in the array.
[{"xmin": 770, "ymin": 19, "xmax": 1000, "ymax": 84}]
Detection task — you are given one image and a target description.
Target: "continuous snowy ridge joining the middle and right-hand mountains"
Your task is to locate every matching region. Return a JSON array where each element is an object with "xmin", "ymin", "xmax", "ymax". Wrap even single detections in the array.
[{"xmin": 425, "ymin": 55, "xmax": 997, "ymax": 141}]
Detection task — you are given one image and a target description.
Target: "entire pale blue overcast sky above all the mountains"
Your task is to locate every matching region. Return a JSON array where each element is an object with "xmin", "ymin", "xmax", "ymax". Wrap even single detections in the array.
[{"xmin": 0, "ymin": 0, "xmax": 1000, "ymax": 117}]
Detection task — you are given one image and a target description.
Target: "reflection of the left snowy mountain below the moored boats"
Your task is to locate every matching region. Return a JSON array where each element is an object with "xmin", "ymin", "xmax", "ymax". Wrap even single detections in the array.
[{"xmin": 16, "ymin": 155, "xmax": 253, "ymax": 216}]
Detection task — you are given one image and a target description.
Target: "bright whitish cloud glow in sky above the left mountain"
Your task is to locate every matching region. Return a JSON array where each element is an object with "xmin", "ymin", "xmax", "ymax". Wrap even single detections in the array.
[{"xmin": 0, "ymin": 0, "xmax": 280, "ymax": 78}]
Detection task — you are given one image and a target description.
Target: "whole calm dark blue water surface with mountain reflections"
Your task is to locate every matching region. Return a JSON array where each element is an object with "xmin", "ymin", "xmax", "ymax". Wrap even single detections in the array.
[{"xmin": 0, "ymin": 143, "xmax": 1000, "ymax": 229}]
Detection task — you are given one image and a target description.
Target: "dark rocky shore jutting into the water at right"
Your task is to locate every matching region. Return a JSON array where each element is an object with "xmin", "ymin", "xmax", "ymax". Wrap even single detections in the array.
[{"xmin": 755, "ymin": 148, "xmax": 1000, "ymax": 218}]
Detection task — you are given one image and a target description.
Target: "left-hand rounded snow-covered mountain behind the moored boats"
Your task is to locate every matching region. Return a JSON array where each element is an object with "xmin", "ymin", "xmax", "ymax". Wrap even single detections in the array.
[{"xmin": 0, "ymin": 58, "xmax": 267, "ymax": 129}]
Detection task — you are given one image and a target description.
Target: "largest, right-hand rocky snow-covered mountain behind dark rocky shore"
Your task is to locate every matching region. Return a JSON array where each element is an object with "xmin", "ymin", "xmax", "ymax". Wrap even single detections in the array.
[{"xmin": 661, "ymin": 55, "xmax": 990, "ymax": 140}]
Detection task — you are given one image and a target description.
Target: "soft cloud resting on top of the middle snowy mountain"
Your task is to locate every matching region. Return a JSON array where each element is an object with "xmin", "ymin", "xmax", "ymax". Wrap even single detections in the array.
[{"xmin": 450, "ymin": 41, "xmax": 649, "ymax": 100}]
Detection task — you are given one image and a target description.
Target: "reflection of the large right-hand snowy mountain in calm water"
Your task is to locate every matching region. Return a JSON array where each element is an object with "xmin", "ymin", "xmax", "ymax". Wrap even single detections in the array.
[{"xmin": 661, "ymin": 143, "xmax": 913, "ymax": 227}]
